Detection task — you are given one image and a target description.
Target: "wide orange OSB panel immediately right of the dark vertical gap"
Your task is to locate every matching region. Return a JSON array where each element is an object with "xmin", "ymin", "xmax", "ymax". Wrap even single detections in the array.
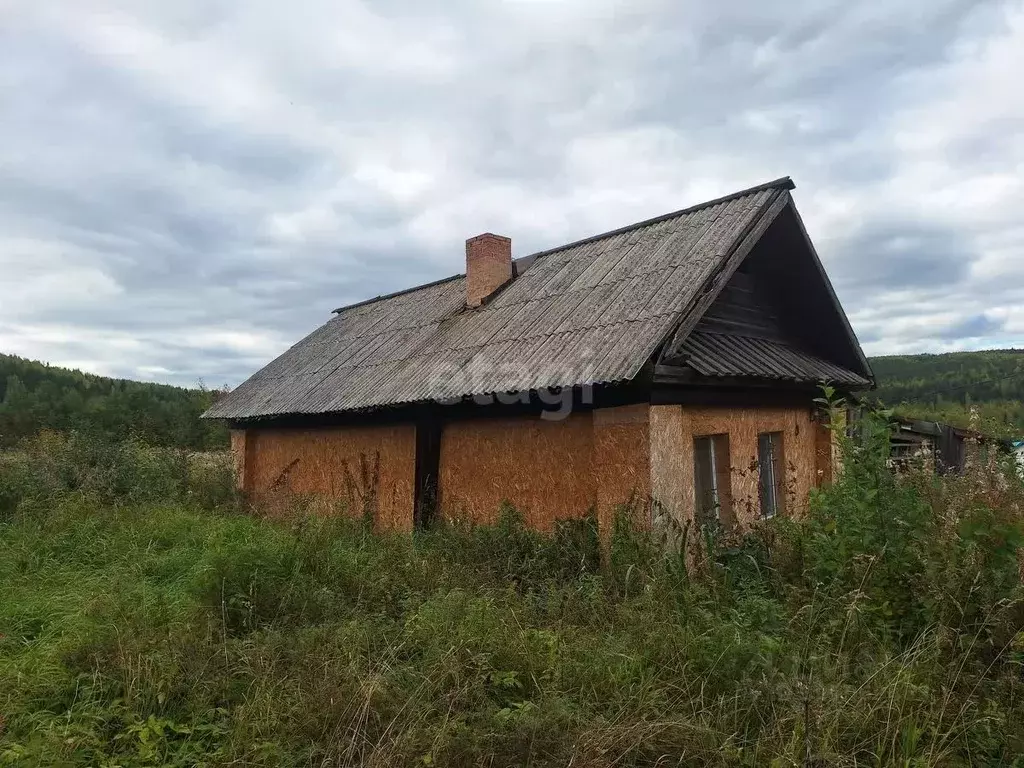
[{"xmin": 438, "ymin": 414, "xmax": 594, "ymax": 530}]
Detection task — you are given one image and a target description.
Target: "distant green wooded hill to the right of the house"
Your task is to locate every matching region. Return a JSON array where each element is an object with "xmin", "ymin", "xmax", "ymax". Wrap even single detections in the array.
[{"xmin": 870, "ymin": 349, "xmax": 1024, "ymax": 436}]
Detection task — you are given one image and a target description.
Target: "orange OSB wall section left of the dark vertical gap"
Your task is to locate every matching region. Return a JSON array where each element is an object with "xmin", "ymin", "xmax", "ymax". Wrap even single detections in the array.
[{"xmin": 241, "ymin": 424, "xmax": 416, "ymax": 530}]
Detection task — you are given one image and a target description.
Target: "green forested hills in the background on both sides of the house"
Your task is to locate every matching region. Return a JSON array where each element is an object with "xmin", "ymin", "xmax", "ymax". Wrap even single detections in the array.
[{"xmin": 0, "ymin": 349, "xmax": 1024, "ymax": 451}]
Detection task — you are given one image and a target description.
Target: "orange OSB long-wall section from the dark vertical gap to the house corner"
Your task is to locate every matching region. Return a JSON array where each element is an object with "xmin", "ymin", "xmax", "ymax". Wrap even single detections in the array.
[{"xmin": 438, "ymin": 404, "xmax": 649, "ymax": 530}]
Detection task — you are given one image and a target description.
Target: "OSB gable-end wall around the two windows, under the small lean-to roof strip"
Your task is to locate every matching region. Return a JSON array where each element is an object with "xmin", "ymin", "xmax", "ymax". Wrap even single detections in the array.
[{"xmin": 650, "ymin": 406, "xmax": 830, "ymax": 525}]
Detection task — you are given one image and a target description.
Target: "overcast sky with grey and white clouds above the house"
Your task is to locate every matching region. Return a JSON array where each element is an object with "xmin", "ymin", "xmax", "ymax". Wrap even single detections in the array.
[{"xmin": 0, "ymin": 0, "xmax": 1024, "ymax": 386}]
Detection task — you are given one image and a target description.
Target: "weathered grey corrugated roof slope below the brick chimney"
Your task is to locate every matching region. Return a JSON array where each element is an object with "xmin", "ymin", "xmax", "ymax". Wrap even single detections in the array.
[{"xmin": 206, "ymin": 178, "xmax": 839, "ymax": 419}]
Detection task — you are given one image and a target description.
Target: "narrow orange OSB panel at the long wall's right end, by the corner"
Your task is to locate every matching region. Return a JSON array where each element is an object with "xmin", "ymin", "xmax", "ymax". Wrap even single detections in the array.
[{"xmin": 593, "ymin": 403, "xmax": 650, "ymax": 531}]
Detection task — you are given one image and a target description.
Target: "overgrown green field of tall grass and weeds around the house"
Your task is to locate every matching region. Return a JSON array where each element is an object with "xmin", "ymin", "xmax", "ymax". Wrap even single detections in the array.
[{"xmin": 0, "ymin": 428, "xmax": 1024, "ymax": 767}]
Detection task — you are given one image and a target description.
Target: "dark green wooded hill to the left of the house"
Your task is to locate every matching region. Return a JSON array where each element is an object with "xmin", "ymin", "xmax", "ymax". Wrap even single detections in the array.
[{"xmin": 0, "ymin": 354, "xmax": 227, "ymax": 451}]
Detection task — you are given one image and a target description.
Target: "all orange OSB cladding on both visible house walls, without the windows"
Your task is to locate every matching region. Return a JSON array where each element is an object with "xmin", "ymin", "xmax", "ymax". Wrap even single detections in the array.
[{"xmin": 231, "ymin": 403, "xmax": 834, "ymax": 530}]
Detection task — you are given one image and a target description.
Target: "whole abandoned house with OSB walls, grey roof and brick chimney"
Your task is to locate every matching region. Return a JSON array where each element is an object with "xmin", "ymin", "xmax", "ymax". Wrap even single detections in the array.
[{"xmin": 206, "ymin": 178, "xmax": 871, "ymax": 530}]
